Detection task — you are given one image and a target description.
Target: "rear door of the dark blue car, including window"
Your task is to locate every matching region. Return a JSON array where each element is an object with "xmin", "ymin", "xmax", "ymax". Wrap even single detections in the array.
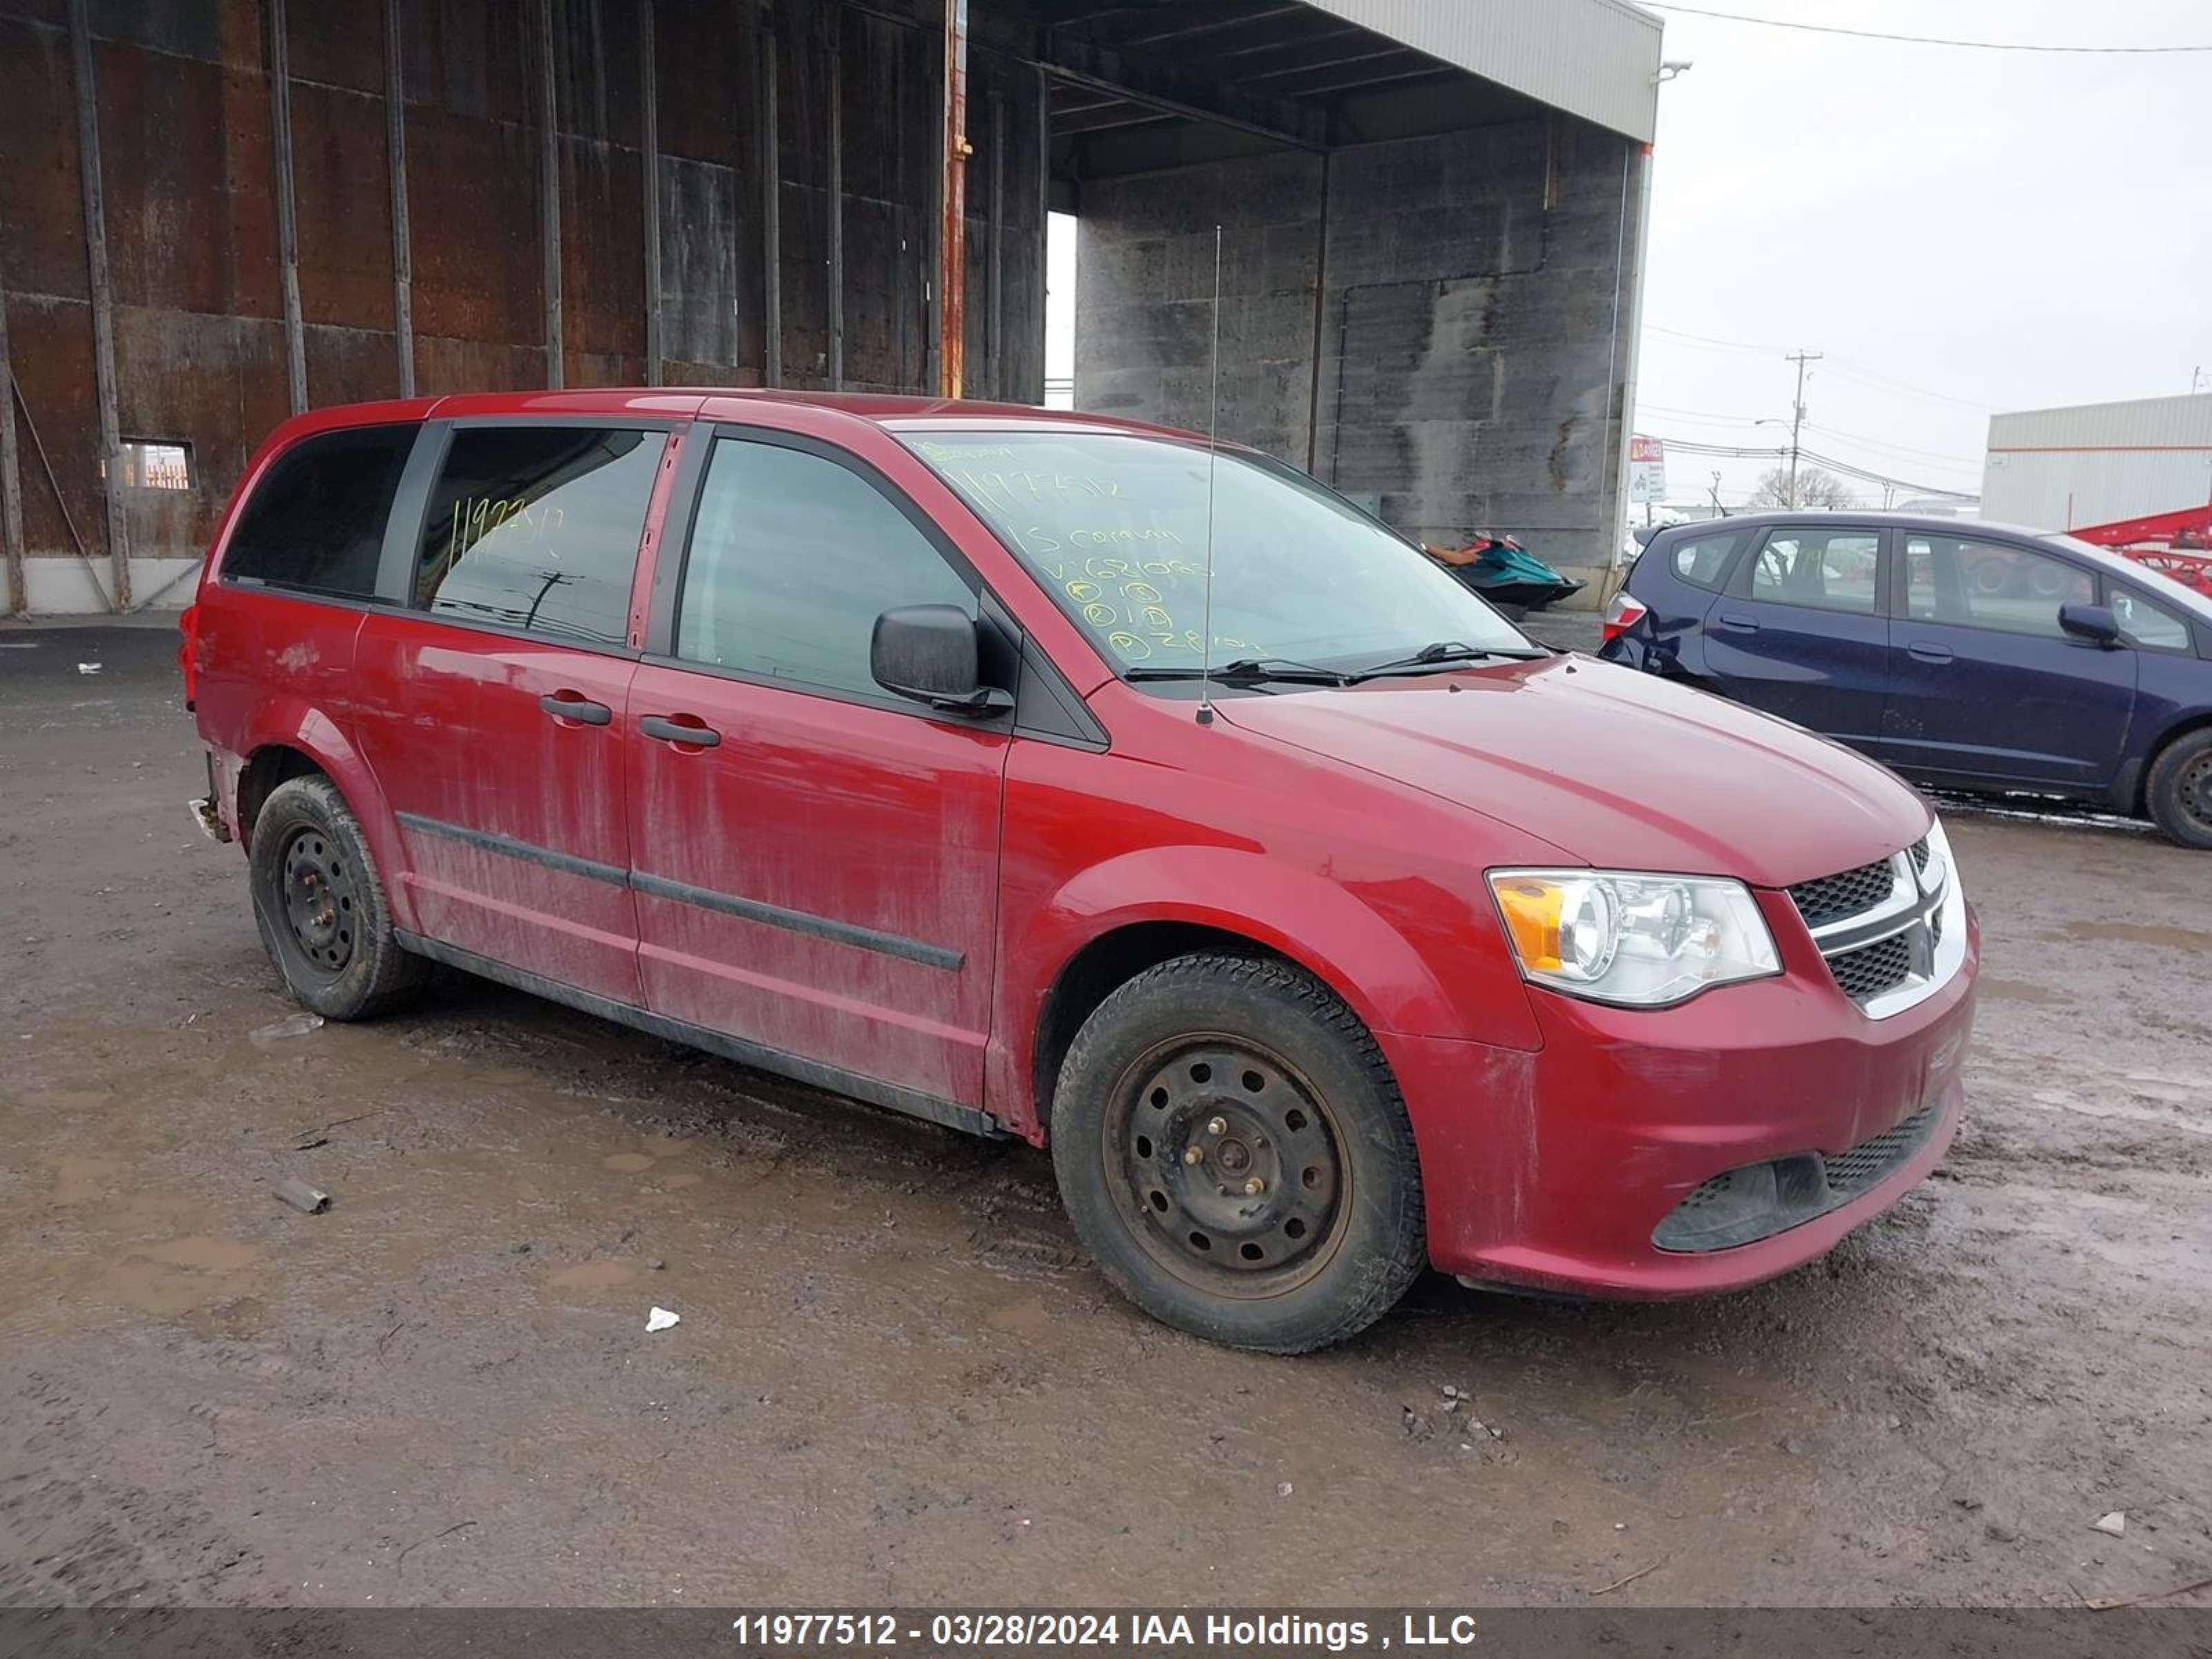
[{"xmin": 1705, "ymin": 524, "xmax": 1889, "ymax": 754}]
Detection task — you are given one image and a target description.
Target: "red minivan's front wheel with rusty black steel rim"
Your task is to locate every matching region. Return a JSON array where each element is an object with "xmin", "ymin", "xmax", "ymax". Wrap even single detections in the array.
[{"xmin": 1051, "ymin": 955, "xmax": 1427, "ymax": 1353}]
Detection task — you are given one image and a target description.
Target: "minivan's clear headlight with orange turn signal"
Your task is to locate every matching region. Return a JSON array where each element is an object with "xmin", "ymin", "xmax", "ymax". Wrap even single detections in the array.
[{"xmin": 1491, "ymin": 870, "xmax": 1781, "ymax": 1009}]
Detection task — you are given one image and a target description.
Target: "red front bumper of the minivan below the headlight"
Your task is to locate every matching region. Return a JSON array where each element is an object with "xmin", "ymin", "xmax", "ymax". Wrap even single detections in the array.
[{"xmin": 1382, "ymin": 911, "xmax": 1980, "ymax": 1296}]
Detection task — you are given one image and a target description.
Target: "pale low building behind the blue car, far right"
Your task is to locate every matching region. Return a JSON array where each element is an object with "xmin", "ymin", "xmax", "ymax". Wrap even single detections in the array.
[{"xmin": 1982, "ymin": 391, "xmax": 2212, "ymax": 531}]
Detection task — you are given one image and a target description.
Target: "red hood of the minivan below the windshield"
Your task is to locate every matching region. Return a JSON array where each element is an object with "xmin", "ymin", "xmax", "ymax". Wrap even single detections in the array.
[{"xmin": 1215, "ymin": 657, "xmax": 1931, "ymax": 887}]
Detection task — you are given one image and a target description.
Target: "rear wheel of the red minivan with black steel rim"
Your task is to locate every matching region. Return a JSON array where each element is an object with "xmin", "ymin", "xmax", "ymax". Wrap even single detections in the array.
[{"xmin": 247, "ymin": 776, "xmax": 429, "ymax": 1020}]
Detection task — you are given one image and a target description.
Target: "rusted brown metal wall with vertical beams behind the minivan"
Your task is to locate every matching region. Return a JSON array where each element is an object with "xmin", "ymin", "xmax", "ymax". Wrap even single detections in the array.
[{"xmin": 0, "ymin": 0, "xmax": 1044, "ymax": 610}]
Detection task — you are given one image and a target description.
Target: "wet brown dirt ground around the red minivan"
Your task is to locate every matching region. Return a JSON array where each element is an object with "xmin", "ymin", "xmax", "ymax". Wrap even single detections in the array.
[{"xmin": 0, "ymin": 628, "xmax": 2212, "ymax": 1606}]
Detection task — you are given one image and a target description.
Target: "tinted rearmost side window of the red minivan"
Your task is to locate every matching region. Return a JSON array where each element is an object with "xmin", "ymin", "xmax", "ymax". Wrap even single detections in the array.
[{"xmin": 223, "ymin": 424, "xmax": 418, "ymax": 599}]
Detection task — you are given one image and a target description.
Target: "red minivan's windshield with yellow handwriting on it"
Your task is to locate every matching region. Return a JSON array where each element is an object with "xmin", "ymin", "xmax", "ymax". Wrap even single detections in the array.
[{"xmin": 903, "ymin": 431, "xmax": 1528, "ymax": 679}]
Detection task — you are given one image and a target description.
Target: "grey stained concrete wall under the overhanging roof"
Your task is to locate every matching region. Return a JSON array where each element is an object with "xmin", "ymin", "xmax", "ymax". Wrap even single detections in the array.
[{"xmin": 1075, "ymin": 118, "xmax": 1644, "ymax": 571}]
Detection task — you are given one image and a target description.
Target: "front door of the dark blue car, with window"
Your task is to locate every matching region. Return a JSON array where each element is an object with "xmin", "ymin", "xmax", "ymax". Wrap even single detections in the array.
[{"xmin": 1882, "ymin": 531, "xmax": 2137, "ymax": 789}]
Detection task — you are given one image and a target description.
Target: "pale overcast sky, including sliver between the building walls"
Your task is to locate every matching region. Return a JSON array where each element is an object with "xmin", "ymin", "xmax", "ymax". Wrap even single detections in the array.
[{"xmin": 1047, "ymin": 0, "xmax": 2212, "ymax": 505}]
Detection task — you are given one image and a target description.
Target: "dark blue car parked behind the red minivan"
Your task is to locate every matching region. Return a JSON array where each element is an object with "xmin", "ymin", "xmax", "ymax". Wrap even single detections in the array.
[{"xmin": 1600, "ymin": 513, "xmax": 2212, "ymax": 850}]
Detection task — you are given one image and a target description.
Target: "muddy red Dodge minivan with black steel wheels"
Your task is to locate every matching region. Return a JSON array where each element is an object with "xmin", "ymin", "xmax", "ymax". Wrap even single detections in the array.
[{"xmin": 184, "ymin": 391, "xmax": 1978, "ymax": 1351}]
